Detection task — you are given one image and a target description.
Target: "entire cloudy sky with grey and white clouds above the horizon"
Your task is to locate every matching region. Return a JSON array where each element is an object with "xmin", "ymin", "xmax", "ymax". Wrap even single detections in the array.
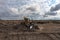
[{"xmin": 0, "ymin": 0, "xmax": 60, "ymax": 20}]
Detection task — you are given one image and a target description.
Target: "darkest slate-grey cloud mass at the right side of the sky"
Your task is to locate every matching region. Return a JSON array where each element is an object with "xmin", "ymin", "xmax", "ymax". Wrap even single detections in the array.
[{"xmin": 44, "ymin": 4, "xmax": 60, "ymax": 17}]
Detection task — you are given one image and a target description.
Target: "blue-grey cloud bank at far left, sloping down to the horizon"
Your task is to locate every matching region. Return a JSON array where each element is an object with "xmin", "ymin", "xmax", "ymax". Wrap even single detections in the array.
[{"xmin": 0, "ymin": 7, "xmax": 19, "ymax": 20}]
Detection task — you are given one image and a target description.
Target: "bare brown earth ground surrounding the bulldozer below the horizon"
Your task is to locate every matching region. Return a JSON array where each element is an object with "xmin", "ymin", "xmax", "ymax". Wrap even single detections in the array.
[{"xmin": 0, "ymin": 20, "xmax": 60, "ymax": 40}]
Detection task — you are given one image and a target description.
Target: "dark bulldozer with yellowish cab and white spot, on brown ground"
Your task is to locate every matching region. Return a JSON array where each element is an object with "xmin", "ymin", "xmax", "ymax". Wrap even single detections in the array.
[{"xmin": 15, "ymin": 17, "xmax": 39, "ymax": 31}]
